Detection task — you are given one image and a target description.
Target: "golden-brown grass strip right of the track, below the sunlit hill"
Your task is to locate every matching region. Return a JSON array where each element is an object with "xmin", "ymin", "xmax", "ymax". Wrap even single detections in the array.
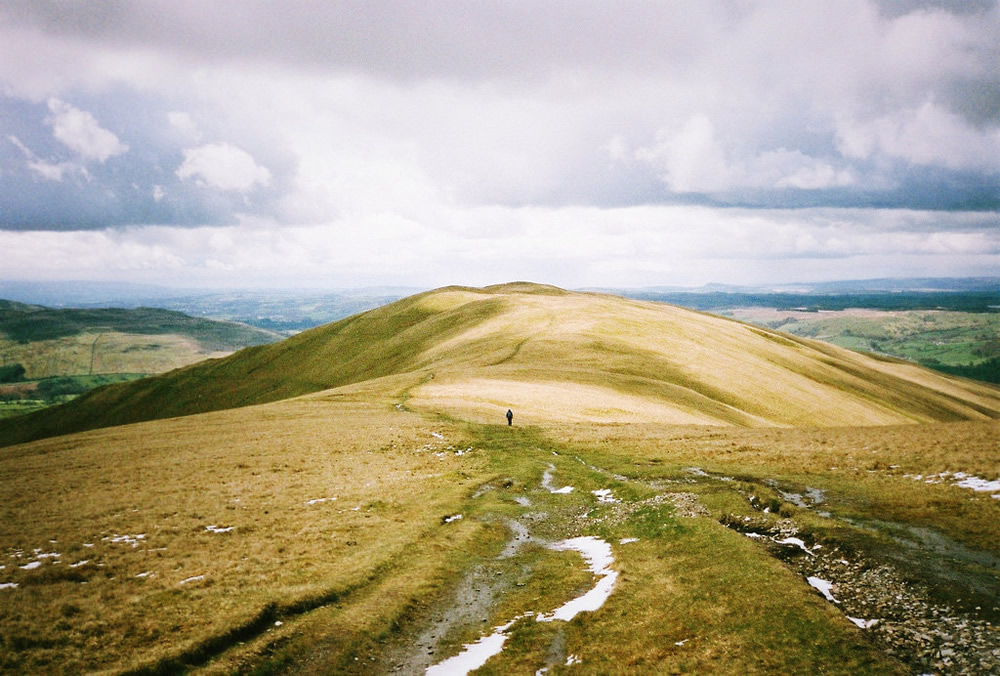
[{"xmin": 542, "ymin": 421, "xmax": 1000, "ymax": 555}]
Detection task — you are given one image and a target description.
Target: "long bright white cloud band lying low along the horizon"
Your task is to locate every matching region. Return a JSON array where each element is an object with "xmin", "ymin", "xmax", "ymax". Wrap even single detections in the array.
[{"xmin": 0, "ymin": 206, "xmax": 1000, "ymax": 287}]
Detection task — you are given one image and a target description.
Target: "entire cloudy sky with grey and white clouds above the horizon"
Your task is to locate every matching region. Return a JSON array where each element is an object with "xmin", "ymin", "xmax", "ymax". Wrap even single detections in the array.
[{"xmin": 0, "ymin": 0, "xmax": 1000, "ymax": 287}]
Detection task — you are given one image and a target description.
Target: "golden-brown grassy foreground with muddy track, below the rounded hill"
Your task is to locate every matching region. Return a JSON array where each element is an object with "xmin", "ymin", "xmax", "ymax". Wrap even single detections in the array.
[{"xmin": 0, "ymin": 388, "xmax": 1000, "ymax": 674}]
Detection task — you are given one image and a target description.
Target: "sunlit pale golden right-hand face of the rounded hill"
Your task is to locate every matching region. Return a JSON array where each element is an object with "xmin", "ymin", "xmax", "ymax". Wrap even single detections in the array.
[{"xmin": 402, "ymin": 294, "xmax": 1000, "ymax": 426}]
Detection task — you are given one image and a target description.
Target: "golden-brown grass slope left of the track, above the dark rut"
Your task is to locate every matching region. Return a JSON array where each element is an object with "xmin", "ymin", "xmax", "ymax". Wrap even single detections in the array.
[{"xmin": 0, "ymin": 388, "xmax": 483, "ymax": 672}]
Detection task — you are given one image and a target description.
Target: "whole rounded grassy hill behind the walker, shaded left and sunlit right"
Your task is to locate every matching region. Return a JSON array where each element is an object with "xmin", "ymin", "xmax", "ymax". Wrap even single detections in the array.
[{"xmin": 0, "ymin": 282, "xmax": 1000, "ymax": 445}]
